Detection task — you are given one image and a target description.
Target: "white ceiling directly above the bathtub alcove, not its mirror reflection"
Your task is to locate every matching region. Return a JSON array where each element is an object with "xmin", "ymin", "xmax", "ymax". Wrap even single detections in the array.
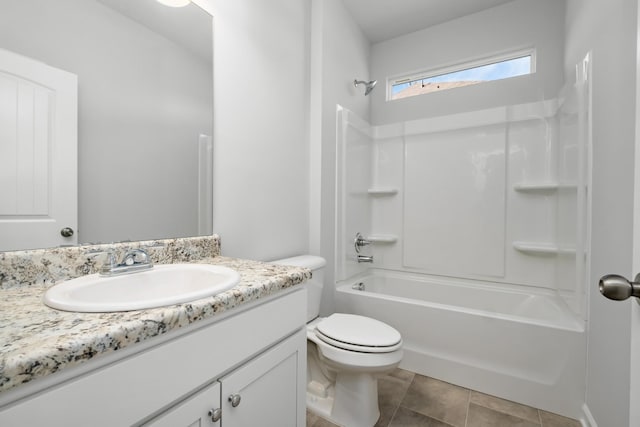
[{"xmin": 343, "ymin": 0, "xmax": 512, "ymax": 43}]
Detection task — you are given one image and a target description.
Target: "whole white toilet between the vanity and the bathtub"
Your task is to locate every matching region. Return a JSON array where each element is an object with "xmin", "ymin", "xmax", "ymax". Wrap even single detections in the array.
[{"xmin": 272, "ymin": 255, "xmax": 403, "ymax": 427}]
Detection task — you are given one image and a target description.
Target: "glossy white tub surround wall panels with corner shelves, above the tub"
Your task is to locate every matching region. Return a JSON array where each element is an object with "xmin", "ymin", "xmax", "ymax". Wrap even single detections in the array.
[{"xmin": 336, "ymin": 82, "xmax": 588, "ymax": 319}]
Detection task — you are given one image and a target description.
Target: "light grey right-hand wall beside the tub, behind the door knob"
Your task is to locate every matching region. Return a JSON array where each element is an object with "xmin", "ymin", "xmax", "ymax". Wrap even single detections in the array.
[{"xmin": 565, "ymin": 0, "xmax": 638, "ymax": 427}]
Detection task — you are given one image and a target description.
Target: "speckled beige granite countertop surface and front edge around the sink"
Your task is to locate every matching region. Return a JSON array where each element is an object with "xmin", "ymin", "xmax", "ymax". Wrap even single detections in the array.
[{"xmin": 0, "ymin": 256, "xmax": 311, "ymax": 393}]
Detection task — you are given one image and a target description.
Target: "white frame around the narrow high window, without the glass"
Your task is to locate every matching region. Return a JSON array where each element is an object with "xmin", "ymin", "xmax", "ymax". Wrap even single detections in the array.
[{"xmin": 386, "ymin": 47, "xmax": 537, "ymax": 101}]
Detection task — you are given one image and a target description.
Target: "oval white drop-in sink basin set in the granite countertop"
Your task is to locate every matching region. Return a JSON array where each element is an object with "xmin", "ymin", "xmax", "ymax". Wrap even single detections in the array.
[{"xmin": 44, "ymin": 264, "xmax": 240, "ymax": 312}]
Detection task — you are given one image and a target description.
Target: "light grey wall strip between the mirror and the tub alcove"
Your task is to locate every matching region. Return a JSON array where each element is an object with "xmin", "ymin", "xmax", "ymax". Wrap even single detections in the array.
[{"xmin": 209, "ymin": 0, "xmax": 309, "ymax": 260}]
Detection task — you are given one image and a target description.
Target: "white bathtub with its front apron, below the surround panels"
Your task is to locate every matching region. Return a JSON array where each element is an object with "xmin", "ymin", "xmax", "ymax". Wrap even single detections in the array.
[{"xmin": 336, "ymin": 270, "xmax": 586, "ymax": 418}]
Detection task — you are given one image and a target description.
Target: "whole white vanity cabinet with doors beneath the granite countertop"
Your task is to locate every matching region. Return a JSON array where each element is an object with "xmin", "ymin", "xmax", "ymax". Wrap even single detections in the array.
[{"xmin": 0, "ymin": 287, "xmax": 306, "ymax": 427}]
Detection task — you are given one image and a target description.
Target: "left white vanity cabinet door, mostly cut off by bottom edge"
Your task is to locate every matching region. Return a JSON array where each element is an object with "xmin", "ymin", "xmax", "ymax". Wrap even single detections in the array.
[{"xmin": 144, "ymin": 382, "xmax": 220, "ymax": 427}]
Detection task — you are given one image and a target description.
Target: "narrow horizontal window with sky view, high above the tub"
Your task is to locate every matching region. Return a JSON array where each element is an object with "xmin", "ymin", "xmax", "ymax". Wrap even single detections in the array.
[{"xmin": 387, "ymin": 50, "xmax": 535, "ymax": 101}]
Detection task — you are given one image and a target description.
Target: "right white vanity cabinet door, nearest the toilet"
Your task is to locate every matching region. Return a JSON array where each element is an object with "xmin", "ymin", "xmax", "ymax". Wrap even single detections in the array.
[{"xmin": 220, "ymin": 330, "xmax": 307, "ymax": 427}]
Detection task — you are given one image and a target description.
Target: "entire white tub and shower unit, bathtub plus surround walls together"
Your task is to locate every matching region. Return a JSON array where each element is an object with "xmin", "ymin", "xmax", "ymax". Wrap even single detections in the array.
[{"xmin": 336, "ymin": 57, "xmax": 591, "ymax": 418}]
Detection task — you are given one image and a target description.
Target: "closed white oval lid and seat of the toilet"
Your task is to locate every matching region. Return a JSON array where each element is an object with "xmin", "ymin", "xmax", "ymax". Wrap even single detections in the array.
[{"xmin": 316, "ymin": 313, "xmax": 402, "ymax": 353}]
